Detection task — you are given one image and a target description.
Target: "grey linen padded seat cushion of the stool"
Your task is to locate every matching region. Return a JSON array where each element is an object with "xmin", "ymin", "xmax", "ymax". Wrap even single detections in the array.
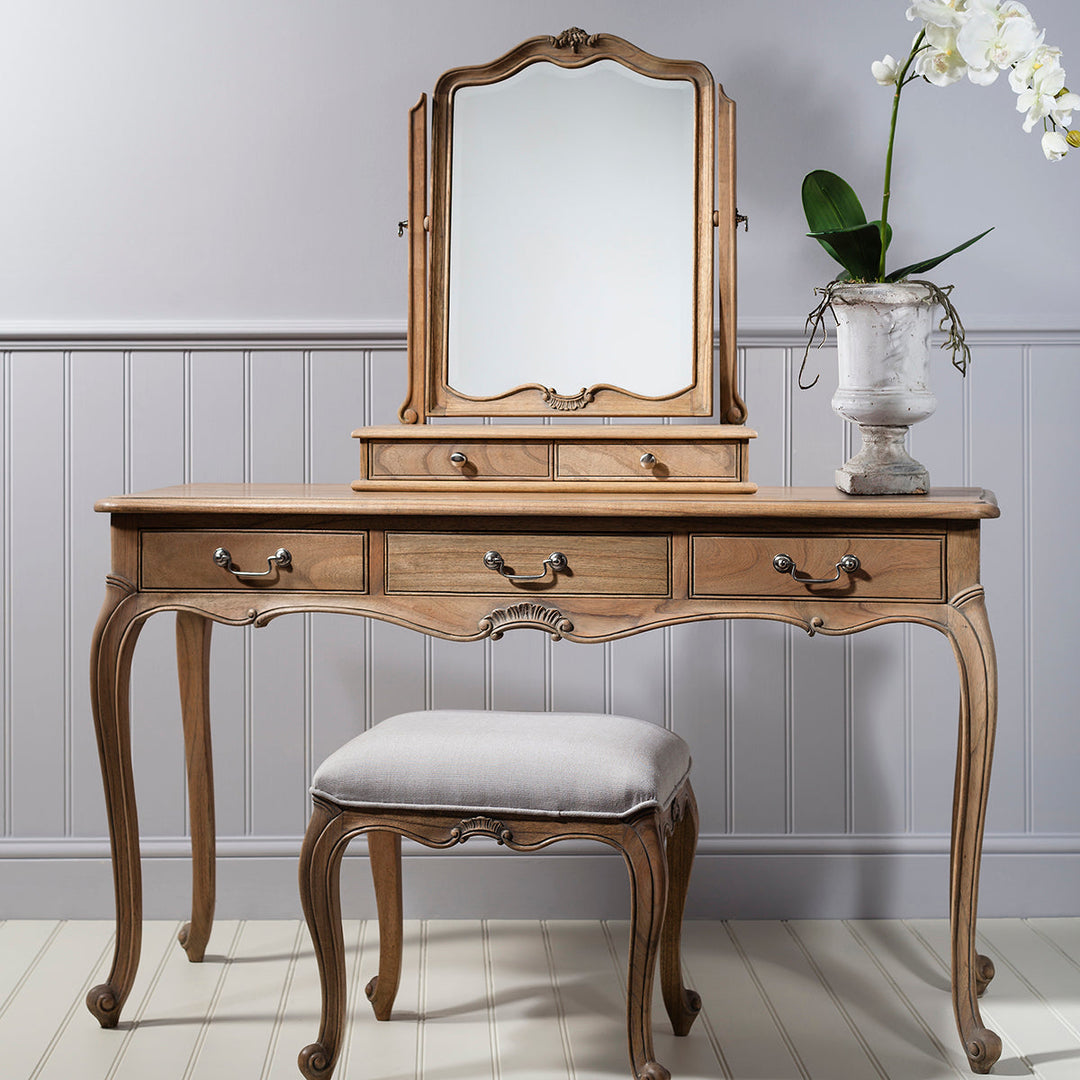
[{"xmin": 311, "ymin": 710, "xmax": 690, "ymax": 819}]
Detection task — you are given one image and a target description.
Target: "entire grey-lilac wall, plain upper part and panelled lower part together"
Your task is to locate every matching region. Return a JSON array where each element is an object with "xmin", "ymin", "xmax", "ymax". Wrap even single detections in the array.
[{"xmin": 0, "ymin": 0, "xmax": 1080, "ymax": 916}]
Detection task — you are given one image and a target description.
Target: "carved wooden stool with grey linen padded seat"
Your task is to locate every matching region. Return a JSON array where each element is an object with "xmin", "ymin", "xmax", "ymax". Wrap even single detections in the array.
[{"xmin": 299, "ymin": 710, "xmax": 701, "ymax": 1080}]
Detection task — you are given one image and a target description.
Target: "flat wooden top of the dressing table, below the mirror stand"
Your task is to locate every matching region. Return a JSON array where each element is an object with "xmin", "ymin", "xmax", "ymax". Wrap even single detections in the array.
[{"xmin": 94, "ymin": 482, "xmax": 1000, "ymax": 521}]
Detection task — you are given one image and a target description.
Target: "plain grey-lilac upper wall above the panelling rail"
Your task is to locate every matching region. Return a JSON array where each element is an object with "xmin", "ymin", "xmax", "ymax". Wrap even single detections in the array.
[{"xmin": 0, "ymin": 0, "xmax": 1080, "ymax": 328}]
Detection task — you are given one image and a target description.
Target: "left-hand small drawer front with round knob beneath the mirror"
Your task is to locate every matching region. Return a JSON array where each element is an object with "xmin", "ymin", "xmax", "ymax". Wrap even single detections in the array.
[{"xmin": 369, "ymin": 440, "xmax": 551, "ymax": 481}]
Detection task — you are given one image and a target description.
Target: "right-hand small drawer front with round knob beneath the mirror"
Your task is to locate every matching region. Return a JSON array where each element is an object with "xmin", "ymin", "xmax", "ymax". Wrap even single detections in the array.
[{"xmin": 555, "ymin": 441, "xmax": 739, "ymax": 481}]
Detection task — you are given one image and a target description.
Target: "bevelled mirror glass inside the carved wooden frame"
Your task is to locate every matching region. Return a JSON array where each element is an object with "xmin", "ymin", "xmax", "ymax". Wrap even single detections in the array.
[{"xmin": 445, "ymin": 59, "xmax": 698, "ymax": 397}]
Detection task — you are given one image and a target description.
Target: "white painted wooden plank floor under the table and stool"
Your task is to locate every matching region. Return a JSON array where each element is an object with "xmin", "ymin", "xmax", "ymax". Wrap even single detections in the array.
[{"xmin": 0, "ymin": 919, "xmax": 1080, "ymax": 1080}]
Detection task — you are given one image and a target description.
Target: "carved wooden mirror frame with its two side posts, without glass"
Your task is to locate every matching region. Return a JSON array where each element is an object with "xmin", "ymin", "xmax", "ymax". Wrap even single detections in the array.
[{"xmin": 399, "ymin": 27, "xmax": 746, "ymax": 423}]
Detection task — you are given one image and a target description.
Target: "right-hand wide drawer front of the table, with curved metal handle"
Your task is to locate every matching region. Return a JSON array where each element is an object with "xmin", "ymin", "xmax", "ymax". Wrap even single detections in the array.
[{"xmin": 690, "ymin": 534, "xmax": 945, "ymax": 600}]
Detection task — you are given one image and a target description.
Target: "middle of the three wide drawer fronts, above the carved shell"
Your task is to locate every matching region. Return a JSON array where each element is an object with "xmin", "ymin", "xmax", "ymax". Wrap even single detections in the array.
[{"xmin": 386, "ymin": 532, "xmax": 671, "ymax": 596}]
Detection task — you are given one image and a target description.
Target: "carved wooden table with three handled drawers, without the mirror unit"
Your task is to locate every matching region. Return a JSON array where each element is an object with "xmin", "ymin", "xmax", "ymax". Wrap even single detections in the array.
[{"xmin": 87, "ymin": 484, "xmax": 1001, "ymax": 1071}]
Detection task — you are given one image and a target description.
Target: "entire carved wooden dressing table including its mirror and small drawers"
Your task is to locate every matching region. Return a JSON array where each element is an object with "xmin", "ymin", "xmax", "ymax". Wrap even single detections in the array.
[{"xmin": 87, "ymin": 29, "xmax": 1001, "ymax": 1072}]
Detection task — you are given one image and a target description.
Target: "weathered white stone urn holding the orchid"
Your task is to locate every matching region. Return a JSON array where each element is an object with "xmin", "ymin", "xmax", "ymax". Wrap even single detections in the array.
[{"xmin": 831, "ymin": 282, "xmax": 937, "ymax": 495}]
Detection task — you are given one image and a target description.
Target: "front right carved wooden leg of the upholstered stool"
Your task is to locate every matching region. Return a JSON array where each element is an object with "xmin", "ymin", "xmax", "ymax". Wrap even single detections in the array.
[{"xmin": 622, "ymin": 814, "xmax": 671, "ymax": 1080}]
